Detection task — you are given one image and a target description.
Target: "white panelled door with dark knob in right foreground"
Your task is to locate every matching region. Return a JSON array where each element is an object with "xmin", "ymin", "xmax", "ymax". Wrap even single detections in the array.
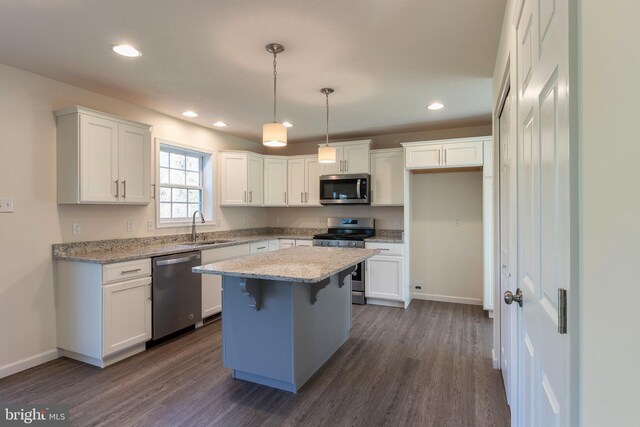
[{"xmin": 511, "ymin": 0, "xmax": 572, "ymax": 426}]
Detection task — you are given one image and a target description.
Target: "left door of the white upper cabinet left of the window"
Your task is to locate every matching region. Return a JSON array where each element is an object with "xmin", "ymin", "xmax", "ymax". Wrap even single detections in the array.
[{"xmin": 79, "ymin": 114, "xmax": 120, "ymax": 203}]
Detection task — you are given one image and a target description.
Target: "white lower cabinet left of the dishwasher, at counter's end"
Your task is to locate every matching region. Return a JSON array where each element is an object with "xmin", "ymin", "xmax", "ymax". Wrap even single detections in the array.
[{"xmin": 55, "ymin": 259, "xmax": 151, "ymax": 367}]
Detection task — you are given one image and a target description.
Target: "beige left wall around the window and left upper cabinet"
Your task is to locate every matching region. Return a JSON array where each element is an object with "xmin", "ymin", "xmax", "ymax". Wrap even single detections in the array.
[{"xmin": 0, "ymin": 64, "xmax": 266, "ymax": 377}]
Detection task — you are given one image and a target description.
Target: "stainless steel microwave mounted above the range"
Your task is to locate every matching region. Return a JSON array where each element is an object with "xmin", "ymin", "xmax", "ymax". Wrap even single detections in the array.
[{"xmin": 320, "ymin": 173, "xmax": 371, "ymax": 205}]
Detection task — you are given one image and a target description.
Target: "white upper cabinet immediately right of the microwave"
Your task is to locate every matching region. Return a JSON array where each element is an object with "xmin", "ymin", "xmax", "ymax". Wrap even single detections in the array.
[{"xmin": 371, "ymin": 148, "xmax": 404, "ymax": 206}]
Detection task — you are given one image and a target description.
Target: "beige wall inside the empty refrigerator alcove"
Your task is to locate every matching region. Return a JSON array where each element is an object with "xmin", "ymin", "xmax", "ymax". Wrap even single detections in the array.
[{"xmin": 411, "ymin": 172, "xmax": 483, "ymax": 304}]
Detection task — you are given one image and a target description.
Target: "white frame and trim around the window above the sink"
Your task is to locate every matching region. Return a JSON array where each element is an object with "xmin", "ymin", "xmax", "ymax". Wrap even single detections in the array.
[{"xmin": 153, "ymin": 138, "xmax": 216, "ymax": 228}]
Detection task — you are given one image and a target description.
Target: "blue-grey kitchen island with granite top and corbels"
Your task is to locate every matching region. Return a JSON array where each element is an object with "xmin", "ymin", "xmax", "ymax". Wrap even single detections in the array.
[{"xmin": 193, "ymin": 246, "xmax": 378, "ymax": 392}]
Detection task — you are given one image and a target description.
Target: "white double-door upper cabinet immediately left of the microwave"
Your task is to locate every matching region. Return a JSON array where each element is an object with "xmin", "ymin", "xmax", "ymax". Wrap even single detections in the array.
[{"xmin": 287, "ymin": 156, "xmax": 320, "ymax": 206}]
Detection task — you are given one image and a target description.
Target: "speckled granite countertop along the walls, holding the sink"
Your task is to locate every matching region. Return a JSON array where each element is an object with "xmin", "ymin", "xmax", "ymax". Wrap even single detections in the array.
[{"xmin": 53, "ymin": 228, "xmax": 402, "ymax": 264}]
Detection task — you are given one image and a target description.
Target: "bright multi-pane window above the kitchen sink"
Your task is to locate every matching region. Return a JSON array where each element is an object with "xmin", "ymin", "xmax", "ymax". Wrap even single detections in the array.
[{"xmin": 157, "ymin": 141, "xmax": 213, "ymax": 226}]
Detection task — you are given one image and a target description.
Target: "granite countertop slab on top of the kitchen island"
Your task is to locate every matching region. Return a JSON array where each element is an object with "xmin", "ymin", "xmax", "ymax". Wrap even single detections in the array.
[{"xmin": 193, "ymin": 246, "xmax": 380, "ymax": 283}]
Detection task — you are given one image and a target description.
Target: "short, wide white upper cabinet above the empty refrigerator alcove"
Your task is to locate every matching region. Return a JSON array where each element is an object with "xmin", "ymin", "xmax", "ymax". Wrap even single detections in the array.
[{"xmin": 402, "ymin": 137, "xmax": 490, "ymax": 169}]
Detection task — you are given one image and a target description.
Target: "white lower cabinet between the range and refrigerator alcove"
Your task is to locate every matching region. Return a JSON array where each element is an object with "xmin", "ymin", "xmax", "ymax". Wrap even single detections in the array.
[{"xmin": 365, "ymin": 243, "xmax": 407, "ymax": 307}]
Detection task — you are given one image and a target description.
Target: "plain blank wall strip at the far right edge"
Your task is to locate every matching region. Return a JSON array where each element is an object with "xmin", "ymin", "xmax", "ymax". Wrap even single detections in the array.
[{"xmin": 578, "ymin": 0, "xmax": 640, "ymax": 426}]
